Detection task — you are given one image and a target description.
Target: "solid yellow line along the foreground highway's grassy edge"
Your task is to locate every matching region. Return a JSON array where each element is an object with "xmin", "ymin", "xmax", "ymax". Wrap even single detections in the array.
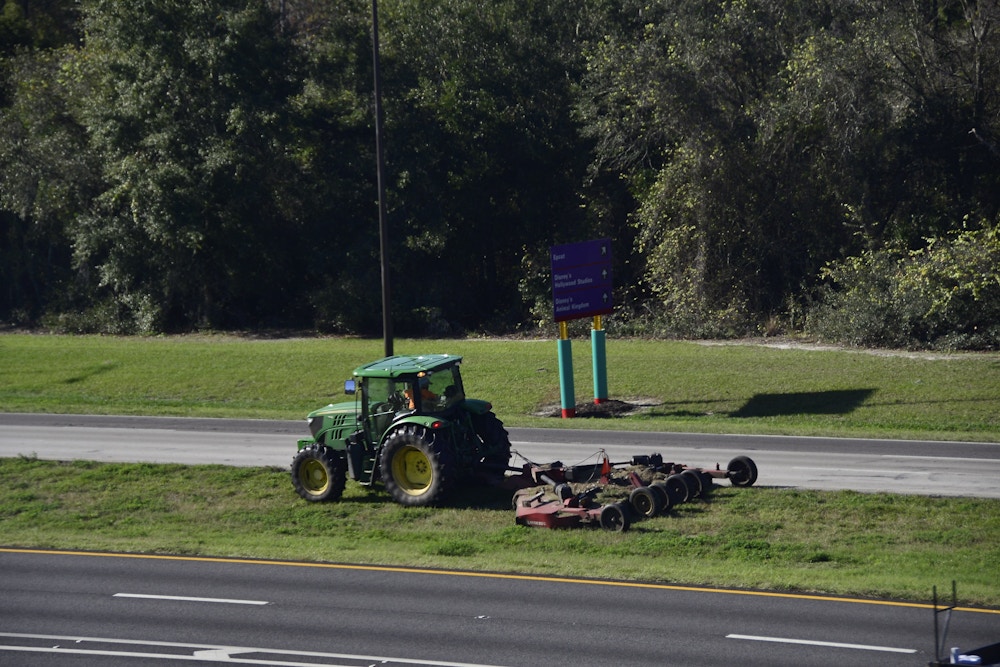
[{"xmin": 0, "ymin": 547, "xmax": 1000, "ymax": 615}]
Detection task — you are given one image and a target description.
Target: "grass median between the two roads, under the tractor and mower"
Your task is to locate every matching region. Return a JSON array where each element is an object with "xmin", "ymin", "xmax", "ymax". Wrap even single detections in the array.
[{"xmin": 0, "ymin": 457, "xmax": 1000, "ymax": 607}]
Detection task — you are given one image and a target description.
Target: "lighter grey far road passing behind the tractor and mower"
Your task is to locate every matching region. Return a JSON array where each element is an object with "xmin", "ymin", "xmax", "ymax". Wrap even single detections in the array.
[{"xmin": 0, "ymin": 413, "xmax": 1000, "ymax": 498}]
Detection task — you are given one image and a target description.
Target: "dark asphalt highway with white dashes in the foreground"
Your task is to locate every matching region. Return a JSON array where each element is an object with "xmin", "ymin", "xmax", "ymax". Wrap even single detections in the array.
[{"xmin": 0, "ymin": 549, "xmax": 1000, "ymax": 667}]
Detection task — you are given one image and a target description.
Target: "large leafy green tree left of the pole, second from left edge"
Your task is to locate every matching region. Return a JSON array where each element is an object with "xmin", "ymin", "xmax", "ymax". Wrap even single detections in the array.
[{"xmin": 73, "ymin": 0, "xmax": 298, "ymax": 331}]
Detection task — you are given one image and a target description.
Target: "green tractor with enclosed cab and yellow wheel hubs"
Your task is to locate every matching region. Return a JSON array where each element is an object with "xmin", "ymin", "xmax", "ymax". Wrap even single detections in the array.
[{"xmin": 291, "ymin": 354, "xmax": 510, "ymax": 507}]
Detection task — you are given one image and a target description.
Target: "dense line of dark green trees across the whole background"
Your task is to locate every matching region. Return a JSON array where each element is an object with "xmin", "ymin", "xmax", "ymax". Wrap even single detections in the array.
[{"xmin": 0, "ymin": 0, "xmax": 1000, "ymax": 349}]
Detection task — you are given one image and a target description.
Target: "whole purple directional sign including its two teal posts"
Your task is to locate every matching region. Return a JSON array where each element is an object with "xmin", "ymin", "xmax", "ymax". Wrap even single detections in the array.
[{"xmin": 551, "ymin": 239, "xmax": 613, "ymax": 419}]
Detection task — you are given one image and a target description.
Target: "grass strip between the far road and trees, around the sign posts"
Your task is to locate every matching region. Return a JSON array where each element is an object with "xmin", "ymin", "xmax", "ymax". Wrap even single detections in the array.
[{"xmin": 0, "ymin": 334, "xmax": 1000, "ymax": 442}]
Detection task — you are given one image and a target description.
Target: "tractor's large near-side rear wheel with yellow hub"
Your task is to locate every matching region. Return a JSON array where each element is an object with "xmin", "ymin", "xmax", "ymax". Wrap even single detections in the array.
[{"xmin": 379, "ymin": 424, "xmax": 455, "ymax": 507}]
